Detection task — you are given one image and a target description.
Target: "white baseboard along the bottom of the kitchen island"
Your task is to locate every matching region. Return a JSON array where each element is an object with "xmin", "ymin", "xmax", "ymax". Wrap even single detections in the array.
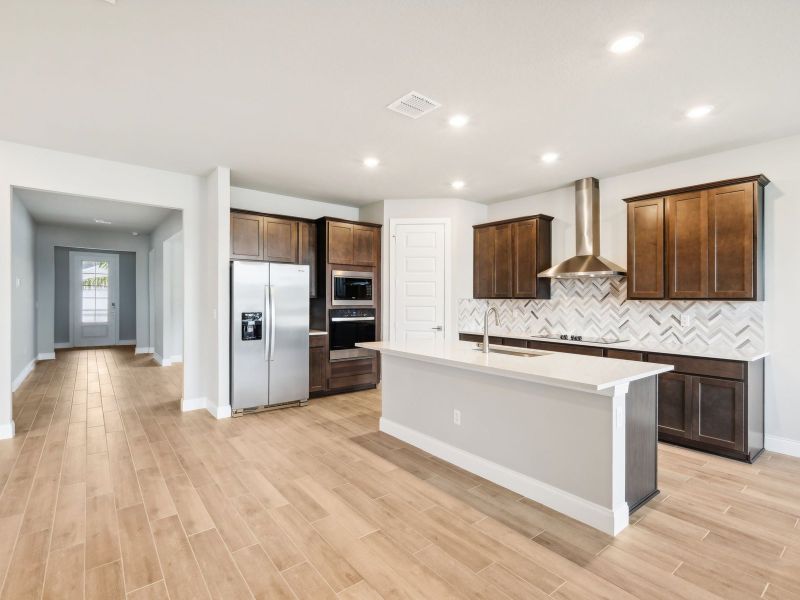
[{"xmin": 380, "ymin": 417, "xmax": 628, "ymax": 535}]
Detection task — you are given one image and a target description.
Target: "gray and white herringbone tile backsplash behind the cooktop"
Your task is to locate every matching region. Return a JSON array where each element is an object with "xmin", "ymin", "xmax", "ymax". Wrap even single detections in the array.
[{"xmin": 458, "ymin": 277, "xmax": 764, "ymax": 350}]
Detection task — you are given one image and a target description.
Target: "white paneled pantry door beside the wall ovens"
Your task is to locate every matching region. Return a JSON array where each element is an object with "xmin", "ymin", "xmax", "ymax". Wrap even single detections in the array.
[{"xmin": 390, "ymin": 222, "xmax": 447, "ymax": 342}]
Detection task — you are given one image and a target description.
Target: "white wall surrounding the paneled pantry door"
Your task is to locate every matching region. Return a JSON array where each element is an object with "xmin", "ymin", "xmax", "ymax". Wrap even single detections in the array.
[{"xmin": 360, "ymin": 198, "xmax": 487, "ymax": 339}]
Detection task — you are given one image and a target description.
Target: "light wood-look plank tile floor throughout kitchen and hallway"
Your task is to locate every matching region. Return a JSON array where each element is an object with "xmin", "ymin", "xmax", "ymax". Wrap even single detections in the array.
[{"xmin": 0, "ymin": 349, "xmax": 800, "ymax": 600}]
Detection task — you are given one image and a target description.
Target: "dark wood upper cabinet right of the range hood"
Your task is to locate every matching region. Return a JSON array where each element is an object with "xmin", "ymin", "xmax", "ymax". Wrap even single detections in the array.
[{"xmin": 625, "ymin": 175, "xmax": 769, "ymax": 300}]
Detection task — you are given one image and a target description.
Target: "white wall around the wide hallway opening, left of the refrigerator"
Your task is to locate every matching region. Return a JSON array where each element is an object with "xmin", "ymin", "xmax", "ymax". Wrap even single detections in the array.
[{"xmin": 0, "ymin": 142, "xmax": 230, "ymax": 437}]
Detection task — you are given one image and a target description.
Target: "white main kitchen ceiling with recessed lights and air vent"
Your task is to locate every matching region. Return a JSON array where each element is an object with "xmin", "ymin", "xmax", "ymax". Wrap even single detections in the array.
[{"xmin": 0, "ymin": 0, "xmax": 800, "ymax": 205}]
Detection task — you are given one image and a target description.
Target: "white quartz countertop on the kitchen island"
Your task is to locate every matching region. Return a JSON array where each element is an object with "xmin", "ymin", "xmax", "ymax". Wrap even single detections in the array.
[{"xmin": 356, "ymin": 342, "xmax": 673, "ymax": 392}]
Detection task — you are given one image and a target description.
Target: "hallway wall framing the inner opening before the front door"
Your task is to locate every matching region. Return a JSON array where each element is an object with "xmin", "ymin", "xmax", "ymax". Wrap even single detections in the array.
[{"xmin": 36, "ymin": 225, "xmax": 149, "ymax": 356}]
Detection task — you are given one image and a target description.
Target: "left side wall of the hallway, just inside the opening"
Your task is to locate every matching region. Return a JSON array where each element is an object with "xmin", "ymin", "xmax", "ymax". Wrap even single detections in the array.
[{"xmin": 10, "ymin": 196, "xmax": 36, "ymax": 389}]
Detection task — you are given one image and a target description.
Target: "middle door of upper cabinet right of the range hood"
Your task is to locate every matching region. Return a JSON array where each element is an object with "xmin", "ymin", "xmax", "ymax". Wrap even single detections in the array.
[{"xmin": 667, "ymin": 190, "xmax": 708, "ymax": 298}]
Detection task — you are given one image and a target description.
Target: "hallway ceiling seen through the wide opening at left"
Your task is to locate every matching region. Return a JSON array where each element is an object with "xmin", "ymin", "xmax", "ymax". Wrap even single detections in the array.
[{"xmin": 14, "ymin": 188, "xmax": 174, "ymax": 234}]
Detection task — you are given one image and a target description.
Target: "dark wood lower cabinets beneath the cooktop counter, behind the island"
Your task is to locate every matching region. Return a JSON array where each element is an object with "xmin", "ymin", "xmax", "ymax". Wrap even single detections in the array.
[{"xmin": 459, "ymin": 333, "xmax": 764, "ymax": 462}]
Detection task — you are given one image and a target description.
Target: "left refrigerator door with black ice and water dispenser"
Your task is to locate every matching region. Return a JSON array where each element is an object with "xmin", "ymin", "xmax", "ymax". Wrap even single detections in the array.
[{"xmin": 231, "ymin": 261, "xmax": 270, "ymax": 410}]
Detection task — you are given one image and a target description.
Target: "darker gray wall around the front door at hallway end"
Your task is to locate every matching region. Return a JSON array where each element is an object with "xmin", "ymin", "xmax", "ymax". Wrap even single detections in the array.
[{"xmin": 53, "ymin": 246, "xmax": 136, "ymax": 344}]
